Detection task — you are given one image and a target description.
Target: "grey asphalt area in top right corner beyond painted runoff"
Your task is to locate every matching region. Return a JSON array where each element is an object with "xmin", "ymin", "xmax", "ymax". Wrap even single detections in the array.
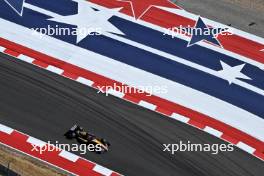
[{"xmin": 173, "ymin": 0, "xmax": 264, "ymax": 37}]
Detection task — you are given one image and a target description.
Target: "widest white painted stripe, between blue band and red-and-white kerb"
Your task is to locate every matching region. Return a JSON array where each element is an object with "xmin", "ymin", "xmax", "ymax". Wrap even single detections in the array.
[{"xmin": 0, "ymin": 15, "xmax": 264, "ymax": 140}]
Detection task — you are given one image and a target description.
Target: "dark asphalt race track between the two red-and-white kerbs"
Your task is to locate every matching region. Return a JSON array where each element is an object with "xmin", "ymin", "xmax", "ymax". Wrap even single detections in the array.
[{"xmin": 0, "ymin": 54, "xmax": 264, "ymax": 176}]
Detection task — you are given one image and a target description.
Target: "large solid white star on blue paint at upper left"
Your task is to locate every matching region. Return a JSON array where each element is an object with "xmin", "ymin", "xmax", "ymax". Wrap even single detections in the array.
[{"xmin": 49, "ymin": 1, "xmax": 125, "ymax": 43}]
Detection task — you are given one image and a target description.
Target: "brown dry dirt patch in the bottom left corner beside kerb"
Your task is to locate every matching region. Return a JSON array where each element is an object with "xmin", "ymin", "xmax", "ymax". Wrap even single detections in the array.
[{"xmin": 0, "ymin": 144, "xmax": 70, "ymax": 176}]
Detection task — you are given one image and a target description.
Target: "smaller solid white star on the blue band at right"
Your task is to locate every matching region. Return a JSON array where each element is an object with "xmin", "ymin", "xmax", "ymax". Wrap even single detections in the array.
[{"xmin": 218, "ymin": 61, "xmax": 252, "ymax": 84}]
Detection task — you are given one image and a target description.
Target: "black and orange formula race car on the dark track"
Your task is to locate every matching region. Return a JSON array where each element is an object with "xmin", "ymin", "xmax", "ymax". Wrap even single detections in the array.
[{"xmin": 64, "ymin": 125, "xmax": 110, "ymax": 154}]
